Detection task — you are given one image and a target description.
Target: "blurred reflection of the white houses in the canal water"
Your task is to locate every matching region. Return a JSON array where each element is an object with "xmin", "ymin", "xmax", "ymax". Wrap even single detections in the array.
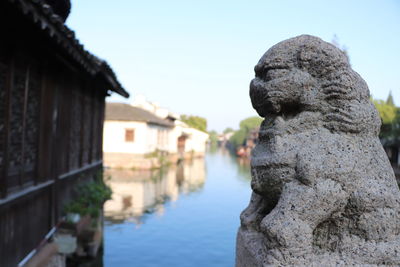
[{"xmin": 104, "ymin": 159, "xmax": 206, "ymax": 224}]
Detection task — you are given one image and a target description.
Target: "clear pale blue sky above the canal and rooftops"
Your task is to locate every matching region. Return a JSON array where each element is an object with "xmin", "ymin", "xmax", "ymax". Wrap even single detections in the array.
[{"xmin": 67, "ymin": 0, "xmax": 400, "ymax": 131}]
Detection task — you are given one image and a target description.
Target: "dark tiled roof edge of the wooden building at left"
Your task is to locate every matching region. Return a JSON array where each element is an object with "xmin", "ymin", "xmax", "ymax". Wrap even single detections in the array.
[{"xmin": 5, "ymin": 0, "xmax": 129, "ymax": 97}]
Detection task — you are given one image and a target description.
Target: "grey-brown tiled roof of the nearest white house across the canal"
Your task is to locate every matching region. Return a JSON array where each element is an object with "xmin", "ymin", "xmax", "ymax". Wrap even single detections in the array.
[{"xmin": 105, "ymin": 103, "xmax": 174, "ymax": 127}]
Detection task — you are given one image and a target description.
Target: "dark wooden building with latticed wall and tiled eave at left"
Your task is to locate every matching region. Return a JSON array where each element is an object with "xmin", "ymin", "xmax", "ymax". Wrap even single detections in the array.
[{"xmin": 0, "ymin": 0, "xmax": 128, "ymax": 266}]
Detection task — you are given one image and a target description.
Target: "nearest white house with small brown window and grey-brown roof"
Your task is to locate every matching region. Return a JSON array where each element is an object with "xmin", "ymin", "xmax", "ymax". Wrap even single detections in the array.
[{"xmin": 103, "ymin": 103, "xmax": 174, "ymax": 168}]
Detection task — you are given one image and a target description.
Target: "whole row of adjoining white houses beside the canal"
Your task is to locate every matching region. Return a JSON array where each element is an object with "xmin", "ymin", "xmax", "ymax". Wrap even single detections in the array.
[{"xmin": 103, "ymin": 100, "xmax": 209, "ymax": 169}]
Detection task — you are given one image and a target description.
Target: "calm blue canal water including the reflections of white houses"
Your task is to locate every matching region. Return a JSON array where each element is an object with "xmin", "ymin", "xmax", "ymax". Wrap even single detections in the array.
[{"xmin": 102, "ymin": 150, "xmax": 251, "ymax": 267}]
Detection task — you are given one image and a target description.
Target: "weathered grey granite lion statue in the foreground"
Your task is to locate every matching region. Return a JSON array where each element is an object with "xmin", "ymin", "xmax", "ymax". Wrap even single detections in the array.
[{"xmin": 236, "ymin": 35, "xmax": 400, "ymax": 266}]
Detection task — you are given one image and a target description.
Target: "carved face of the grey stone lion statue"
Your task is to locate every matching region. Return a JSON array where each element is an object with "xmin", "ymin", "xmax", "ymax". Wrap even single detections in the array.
[{"xmin": 250, "ymin": 44, "xmax": 316, "ymax": 117}]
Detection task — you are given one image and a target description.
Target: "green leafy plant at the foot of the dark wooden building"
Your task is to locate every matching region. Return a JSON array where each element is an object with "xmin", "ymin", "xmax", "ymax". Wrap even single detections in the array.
[{"xmin": 64, "ymin": 175, "xmax": 112, "ymax": 218}]
